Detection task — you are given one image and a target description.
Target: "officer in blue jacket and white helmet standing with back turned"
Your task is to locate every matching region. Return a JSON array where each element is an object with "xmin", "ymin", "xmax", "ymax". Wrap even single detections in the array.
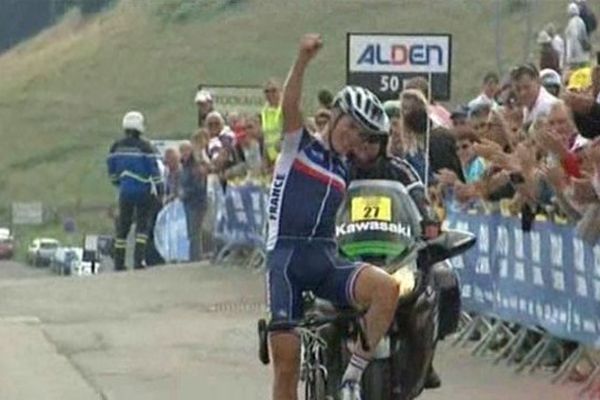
[{"xmin": 107, "ymin": 111, "xmax": 161, "ymax": 271}]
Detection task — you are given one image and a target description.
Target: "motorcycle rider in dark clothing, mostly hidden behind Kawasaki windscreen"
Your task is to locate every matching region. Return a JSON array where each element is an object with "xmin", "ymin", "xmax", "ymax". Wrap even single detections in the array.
[{"xmin": 350, "ymin": 112, "xmax": 460, "ymax": 389}]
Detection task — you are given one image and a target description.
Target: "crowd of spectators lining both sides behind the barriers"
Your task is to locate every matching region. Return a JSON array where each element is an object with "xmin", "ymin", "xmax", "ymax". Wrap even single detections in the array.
[{"xmin": 136, "ymin": 0, "xmax": 600, "ymax": 266}]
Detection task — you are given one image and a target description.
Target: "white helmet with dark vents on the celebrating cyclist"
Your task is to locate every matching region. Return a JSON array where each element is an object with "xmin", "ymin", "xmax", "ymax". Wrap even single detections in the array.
[{"xmin": 333, "ymin": 86, "xmax": 390, "ymax": 136}]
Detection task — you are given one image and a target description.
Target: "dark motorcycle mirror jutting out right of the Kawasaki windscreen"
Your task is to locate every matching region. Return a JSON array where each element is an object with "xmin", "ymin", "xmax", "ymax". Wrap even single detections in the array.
[{"xmin": 419, "ymin": 229, "xmax": 477, "ymax": 264}]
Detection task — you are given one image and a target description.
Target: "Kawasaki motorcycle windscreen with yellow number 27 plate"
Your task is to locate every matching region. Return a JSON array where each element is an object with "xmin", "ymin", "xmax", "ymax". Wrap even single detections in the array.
[{"xmin": 336, "ymin": 180, "xmax": 421, "ymax": 265}]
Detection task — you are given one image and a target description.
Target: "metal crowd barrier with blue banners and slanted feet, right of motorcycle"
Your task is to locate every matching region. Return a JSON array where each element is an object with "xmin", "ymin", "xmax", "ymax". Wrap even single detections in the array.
[{"xmin": 449, "ymin": 213, "xmax": 600, "ymax": 396}]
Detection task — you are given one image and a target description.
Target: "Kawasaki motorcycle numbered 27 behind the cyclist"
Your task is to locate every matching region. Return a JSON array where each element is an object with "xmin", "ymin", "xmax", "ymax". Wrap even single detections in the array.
[{"xmin": 325, "ymin": 180, "xmax": 475, "ymax": 400}]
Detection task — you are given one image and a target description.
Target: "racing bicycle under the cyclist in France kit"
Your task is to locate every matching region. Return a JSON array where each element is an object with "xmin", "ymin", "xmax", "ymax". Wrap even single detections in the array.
[{"xmin": 258, "ymin": 293, "xmax": 369, "ymax": 400}]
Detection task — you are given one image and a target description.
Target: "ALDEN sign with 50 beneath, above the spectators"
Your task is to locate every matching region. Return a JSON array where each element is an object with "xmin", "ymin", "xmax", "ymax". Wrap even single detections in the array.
[{"xmin": 346, "ymin": 33, "xmax": 452, "ymax": 101}]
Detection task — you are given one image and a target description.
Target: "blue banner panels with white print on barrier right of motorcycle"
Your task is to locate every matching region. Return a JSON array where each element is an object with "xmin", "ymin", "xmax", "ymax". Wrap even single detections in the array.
[{"xmin": 448, "ymin": 213, "xmax": 600, "ymax": 346}]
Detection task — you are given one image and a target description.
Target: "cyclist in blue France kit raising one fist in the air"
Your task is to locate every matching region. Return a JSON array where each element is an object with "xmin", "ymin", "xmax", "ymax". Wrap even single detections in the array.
[{"xmin": 267, "ymin": 34, "xmax": 399, "ymax": 400}]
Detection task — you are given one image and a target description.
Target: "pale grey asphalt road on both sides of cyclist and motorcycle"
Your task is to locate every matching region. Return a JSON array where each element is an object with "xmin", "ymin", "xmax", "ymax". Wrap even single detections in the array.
[{"xmin": 0, "ymin": 263, "xmax": 577, "ymax": 400}]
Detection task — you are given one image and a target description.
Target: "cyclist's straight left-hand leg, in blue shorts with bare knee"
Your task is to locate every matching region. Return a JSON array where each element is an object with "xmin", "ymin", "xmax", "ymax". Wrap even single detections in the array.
[{"xmin": 267, "ymin": 247, "xmax": 302, "ymax": 400}]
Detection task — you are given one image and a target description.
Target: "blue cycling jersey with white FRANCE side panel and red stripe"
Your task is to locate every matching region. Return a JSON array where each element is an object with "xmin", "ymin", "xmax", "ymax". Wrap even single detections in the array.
[{"xmin": 267, "ymin": 129, "xmax": 348, "ymax": 250}]
